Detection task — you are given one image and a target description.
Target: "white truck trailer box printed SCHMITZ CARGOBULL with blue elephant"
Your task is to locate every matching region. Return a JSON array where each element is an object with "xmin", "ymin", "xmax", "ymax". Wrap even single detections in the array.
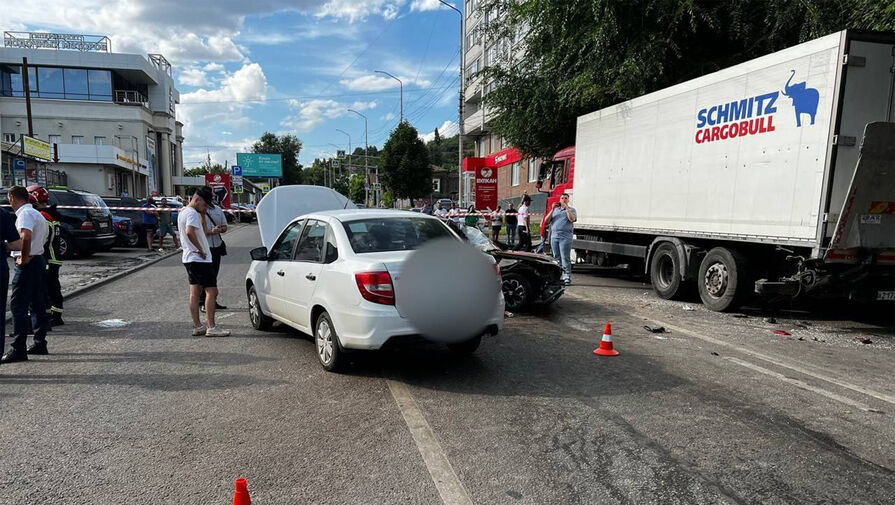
[{"xmin": 572, "ymin": 31, "xmax": 895, "ymax": 308}]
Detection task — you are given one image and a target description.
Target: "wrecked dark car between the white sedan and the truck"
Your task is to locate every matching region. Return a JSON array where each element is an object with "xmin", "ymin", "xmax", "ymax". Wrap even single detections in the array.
[{"xmin": 447, "ymin": 220, "xmax": 566, "ymax": 312}]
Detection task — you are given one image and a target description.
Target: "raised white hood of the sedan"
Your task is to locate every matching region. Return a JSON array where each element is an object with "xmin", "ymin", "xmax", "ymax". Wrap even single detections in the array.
[{"xmin": 255, "ymin": 185, "xmax": 353, "ymax": 249}]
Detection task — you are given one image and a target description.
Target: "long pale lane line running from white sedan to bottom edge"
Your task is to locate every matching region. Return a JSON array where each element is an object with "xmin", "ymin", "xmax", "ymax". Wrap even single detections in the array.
[{"xmin": 386, "ymin": 379, "xmax": 472, "ymax": 505}]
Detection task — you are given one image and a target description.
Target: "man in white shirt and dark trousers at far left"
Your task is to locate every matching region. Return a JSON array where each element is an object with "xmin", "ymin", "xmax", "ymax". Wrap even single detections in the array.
[{"xmin": 0, "ymin": 186, "xmax": 50, "ymax": 363}]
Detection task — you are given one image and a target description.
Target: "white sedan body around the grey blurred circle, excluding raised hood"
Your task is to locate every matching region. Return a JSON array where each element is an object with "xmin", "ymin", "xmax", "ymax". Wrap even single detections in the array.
[{"xmin": 246, "ymin": 209, "xmax": 504, "ymax": 370}]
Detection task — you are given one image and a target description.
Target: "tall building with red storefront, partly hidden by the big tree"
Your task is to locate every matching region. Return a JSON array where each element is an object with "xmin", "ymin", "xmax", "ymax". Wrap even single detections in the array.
[{"xmin": 463, "ymin": 0, "xmax": 546, "ymax": 208}]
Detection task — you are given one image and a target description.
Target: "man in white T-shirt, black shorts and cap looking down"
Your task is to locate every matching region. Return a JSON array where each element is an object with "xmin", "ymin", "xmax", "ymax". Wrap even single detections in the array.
[{"xmin": 177, "ymin": 189, "xmax": 230, "ymax": 337}]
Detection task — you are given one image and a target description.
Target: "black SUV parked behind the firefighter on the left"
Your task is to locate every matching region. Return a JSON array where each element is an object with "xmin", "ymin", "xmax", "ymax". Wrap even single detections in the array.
[{"xmin": 0, "ymin": 188, "xmax": 115, "ymax": 259}]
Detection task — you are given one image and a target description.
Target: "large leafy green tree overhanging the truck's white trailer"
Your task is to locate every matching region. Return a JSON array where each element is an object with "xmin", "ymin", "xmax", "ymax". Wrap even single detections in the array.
[{"xmin": 480, "ymin": 0, "xmax": 895, "ymax": 157}]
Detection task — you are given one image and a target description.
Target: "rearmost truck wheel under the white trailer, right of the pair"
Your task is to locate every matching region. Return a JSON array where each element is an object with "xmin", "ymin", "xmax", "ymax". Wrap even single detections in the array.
[{"xmin": 696, "ymin": 247, "xmax": 754, "ymax": 312}]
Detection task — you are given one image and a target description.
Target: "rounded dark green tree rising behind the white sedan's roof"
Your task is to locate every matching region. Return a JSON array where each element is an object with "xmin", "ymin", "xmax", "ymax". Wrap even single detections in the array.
[{"xmin": 379, "ymin": 121, "xmax": 432, "ymax": 198}]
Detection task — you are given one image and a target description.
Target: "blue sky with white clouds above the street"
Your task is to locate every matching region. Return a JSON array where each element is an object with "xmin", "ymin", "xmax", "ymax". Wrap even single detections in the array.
[{"xmin": 2, "ymin": 0, "xmax": 460, "ymax": 167}]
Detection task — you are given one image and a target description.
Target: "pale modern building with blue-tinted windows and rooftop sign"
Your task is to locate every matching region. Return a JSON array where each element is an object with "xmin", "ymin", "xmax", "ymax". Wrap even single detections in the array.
[{"xmin": 0, "ymin": 32, "xmax": 183, "ymax": 197}]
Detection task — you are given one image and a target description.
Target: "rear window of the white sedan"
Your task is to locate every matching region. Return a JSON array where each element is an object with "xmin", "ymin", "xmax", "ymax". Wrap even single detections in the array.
[{"xmin": 342, "ymin": 217, "xmax": 453, "ymax": 254}]
